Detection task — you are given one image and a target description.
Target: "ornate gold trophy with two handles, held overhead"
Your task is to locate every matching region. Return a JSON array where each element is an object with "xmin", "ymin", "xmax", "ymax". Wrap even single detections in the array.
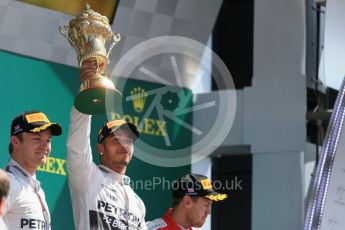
[{"xmin": 59, "ymin": 4, "xmax": 122, "ymax": 114}]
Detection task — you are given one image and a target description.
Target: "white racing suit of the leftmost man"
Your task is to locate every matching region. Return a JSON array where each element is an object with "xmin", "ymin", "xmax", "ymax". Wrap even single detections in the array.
[{"xmin": 3, "ymin": 159, "xmax": 50, "ymax": 230}]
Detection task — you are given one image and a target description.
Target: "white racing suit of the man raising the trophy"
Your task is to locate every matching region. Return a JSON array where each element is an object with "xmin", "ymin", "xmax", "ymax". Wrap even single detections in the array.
[{"xmin": 67, "ymin": 107, "xmax": 146, "ymax": 230}]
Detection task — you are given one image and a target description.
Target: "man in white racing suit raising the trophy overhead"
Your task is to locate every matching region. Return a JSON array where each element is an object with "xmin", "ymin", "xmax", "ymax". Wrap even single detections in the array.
[{"xmin": 67, "ymin": 62, "xmax": 146, "ymax": 230}]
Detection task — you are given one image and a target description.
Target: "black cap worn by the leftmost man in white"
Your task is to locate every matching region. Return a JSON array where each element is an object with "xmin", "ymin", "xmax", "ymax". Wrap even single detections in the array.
[{"xmin": 11, "ymin": 111, "xmax": 62, "ymax": 136}]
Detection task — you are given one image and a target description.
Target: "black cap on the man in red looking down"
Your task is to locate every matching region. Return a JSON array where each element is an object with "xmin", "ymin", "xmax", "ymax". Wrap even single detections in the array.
[{"xmin": 172, "ymin": 174, "xmax": 227, "ymax": 201}]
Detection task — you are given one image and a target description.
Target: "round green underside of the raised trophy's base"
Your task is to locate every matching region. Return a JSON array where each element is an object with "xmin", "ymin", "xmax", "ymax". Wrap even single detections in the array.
[{"xmin": 74, "ymin": 87, "xmax": 122, "ymax": 115}]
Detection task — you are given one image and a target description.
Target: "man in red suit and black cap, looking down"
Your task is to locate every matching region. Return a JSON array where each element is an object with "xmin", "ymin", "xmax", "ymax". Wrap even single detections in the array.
[{"xmin": 147, "ymin": 174, "xmax": 227, "ymax": 230}]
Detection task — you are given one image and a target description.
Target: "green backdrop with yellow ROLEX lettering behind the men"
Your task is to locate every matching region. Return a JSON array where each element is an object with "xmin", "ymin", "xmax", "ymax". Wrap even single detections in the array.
[{"xmin": 0, "ymin": 51, "xmax": 192, "ymax": 229}]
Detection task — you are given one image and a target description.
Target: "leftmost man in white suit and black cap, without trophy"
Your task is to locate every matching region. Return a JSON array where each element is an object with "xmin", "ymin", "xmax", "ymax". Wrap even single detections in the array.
[{"xmin": 4, "ymin": 111, "xmax": 62, "ymax": 230}]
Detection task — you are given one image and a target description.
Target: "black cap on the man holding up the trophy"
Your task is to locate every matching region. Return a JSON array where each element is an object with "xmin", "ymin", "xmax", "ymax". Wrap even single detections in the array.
[{"xmin": 97, "ymin": 120, "xmax": 139, "ymax": 143}]
